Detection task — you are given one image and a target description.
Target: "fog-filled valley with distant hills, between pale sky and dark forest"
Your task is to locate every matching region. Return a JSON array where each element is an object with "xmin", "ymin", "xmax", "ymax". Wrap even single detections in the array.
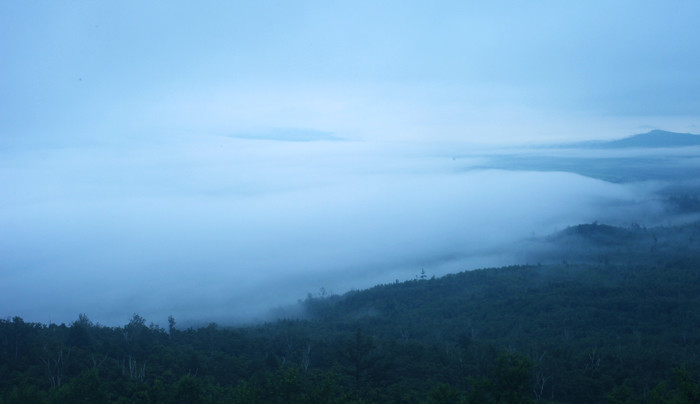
[{"xmin": 0, "ymin": 129, "xmax": 700, "ymax": 325}]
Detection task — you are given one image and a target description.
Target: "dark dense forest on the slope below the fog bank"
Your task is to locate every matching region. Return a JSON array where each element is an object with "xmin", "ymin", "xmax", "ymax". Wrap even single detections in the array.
[{"xmin": 0, "ymin": 222, "xmax": 700, "ymax": 403}]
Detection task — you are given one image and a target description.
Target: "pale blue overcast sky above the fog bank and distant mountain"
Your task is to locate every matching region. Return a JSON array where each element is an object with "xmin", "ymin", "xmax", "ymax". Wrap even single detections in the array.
[{"xmin": 0, "ymin": 0, "xmax": 700, "ymax": 143}]
